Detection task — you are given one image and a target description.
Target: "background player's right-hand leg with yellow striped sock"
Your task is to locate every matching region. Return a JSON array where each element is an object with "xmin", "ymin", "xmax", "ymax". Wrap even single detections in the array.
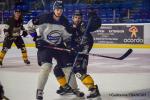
[{"xmin": 14, "ymin": 37, "xmax": 30, "ymax": 64}]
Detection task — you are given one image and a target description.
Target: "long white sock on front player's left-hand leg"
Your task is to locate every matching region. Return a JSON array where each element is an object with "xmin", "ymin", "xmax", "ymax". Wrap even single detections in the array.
[{"xmin": 37, "ymin": 63, "xmax": 52, "ymax": 90}]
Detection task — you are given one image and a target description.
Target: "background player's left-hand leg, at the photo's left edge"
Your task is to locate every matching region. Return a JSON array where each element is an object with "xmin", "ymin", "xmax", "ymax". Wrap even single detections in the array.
[{"xmin": 0, "ymin": 37, "xmax": 13, "ymax": 67}]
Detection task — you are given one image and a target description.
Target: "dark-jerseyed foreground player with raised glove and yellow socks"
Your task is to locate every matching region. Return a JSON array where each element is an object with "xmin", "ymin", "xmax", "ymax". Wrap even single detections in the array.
[{"xmin": 54, "ymin": 10, "xmax": 101, "ymax": 98}]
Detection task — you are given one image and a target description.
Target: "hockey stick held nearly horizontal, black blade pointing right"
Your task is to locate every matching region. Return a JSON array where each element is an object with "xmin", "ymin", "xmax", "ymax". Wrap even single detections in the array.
[{"xmin": 44, "ymin": 47, "xmax": 133, "ymax": 60}]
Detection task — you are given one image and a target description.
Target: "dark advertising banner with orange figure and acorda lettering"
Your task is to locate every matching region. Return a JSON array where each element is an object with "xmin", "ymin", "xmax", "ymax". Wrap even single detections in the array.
[{"xmin": 92, "ymin": 25, "xmax": 144, "ymax": 44}]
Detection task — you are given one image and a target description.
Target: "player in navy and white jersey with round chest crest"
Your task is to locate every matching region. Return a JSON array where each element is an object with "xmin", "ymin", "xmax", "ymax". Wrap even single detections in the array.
[{"xmin": 27, "ymin": 0, "xmax": 82, "ymax": 100}]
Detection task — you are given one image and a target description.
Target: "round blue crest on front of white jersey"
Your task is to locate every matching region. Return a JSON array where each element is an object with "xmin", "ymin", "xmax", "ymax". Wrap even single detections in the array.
[{"xmin": 47, "ymin": 30, "xmax": 61, "ymax": 44}]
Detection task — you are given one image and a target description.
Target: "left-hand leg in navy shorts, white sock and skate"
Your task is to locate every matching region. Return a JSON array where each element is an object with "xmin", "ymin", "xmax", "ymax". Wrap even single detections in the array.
[{"xmin": 36, "ymin": 49, "xmax": 52, "ymax": 100}]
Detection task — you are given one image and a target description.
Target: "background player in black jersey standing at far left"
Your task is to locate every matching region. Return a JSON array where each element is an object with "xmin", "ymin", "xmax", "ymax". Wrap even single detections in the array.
[{"xmin": 0, "ymin": 9, "xmax": 30, "ymax": 67}]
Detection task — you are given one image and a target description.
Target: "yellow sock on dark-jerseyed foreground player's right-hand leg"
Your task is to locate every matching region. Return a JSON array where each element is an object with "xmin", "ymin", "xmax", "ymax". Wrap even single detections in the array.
[{"xmin": 81, "ymin": 75, "xmax": 95, "ymax": 89}]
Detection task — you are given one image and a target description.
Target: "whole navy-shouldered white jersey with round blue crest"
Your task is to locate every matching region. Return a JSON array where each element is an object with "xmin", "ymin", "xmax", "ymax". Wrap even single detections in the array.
[{"xmin": 26, "ymin": 13, "xmax": 71, "ymax": 46}]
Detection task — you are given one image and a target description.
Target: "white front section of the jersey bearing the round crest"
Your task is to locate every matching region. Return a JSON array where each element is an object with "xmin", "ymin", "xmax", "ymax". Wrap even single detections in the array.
[{"xmin": 36, "ymin": 23, "xmax": 71, "ymax": 45}]
